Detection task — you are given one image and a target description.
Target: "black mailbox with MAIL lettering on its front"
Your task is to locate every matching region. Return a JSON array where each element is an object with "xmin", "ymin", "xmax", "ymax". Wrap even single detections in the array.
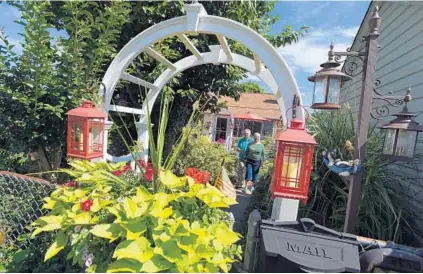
[{"xmin": 257, "ymin": 218, "xmax": 360, "ymax": 273}]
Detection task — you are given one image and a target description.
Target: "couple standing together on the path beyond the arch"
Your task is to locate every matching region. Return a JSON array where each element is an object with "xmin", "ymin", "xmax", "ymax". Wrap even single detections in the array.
[{"xmin": 237, "ymin": 128, "xmax": 264, "ymax": 194}]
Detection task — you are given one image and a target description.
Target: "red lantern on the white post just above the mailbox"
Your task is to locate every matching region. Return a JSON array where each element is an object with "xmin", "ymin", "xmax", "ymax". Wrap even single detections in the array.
[{"xmin": 272, "ymin": 120, "xmax": 317, "ymax": 204}]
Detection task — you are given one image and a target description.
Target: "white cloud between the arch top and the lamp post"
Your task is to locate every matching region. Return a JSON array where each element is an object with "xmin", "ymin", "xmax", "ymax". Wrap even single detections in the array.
[{"xmin": 279, "ymin": 27, "xmax": 358, "ymax": 74}]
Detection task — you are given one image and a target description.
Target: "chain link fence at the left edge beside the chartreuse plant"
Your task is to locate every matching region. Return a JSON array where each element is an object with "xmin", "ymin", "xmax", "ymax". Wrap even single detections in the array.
[{"xmin": 0, "ymin": 171, "xmax": 56, "ymax": 245}]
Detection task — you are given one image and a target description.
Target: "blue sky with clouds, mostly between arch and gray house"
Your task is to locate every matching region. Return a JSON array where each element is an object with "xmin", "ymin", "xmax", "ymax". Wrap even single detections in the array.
[{"xmin": 0, "ymin": 1, "xmax": 370, "ymax": 105}]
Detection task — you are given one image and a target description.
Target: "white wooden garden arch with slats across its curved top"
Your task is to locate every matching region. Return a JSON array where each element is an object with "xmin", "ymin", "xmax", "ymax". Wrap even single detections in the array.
[{"xmin": 99, "ymin": 4, "xmax": 304, "ymax": 162}]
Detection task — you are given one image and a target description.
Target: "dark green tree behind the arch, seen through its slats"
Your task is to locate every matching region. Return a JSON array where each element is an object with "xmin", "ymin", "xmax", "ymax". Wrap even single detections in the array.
[{"xmin": 48, "ymin": 1, "xmax": 307, "ymax": 158}]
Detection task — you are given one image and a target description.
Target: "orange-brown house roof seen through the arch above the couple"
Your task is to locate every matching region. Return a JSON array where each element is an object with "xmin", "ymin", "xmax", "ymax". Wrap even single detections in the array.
[{"xmin": 219, "ymin": 93, "xmax": 281, "ymax": 120}]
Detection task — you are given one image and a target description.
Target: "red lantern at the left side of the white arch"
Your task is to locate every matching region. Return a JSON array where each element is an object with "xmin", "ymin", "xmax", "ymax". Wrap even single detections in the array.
[{"xmin": 66, "ymin": 101, "xmax": 107, "ymax": 160}]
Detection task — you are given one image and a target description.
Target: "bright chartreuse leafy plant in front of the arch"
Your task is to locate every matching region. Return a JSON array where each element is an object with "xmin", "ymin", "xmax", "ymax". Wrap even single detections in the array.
[{"xmin": 32, "ymin": 161, "xmax": 241, "ymax": 273}]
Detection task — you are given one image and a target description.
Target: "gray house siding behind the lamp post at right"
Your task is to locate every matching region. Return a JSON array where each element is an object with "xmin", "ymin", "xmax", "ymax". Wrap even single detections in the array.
[{"xmin": 342, "ymin": 1, "xmax": 423, "ymax": 240}]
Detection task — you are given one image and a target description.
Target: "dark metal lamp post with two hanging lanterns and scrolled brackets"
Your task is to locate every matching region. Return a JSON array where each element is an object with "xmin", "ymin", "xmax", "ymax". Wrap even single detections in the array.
[{"xmin": 309, "ymin": 6, "xmax": 423, "ymax": 233}]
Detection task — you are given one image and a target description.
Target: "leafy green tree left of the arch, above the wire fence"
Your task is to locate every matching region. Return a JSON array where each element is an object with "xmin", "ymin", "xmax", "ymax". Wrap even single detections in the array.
[{"xmin": 0, "ymin": 1, "xmax": 129, "ymax": 178}]
